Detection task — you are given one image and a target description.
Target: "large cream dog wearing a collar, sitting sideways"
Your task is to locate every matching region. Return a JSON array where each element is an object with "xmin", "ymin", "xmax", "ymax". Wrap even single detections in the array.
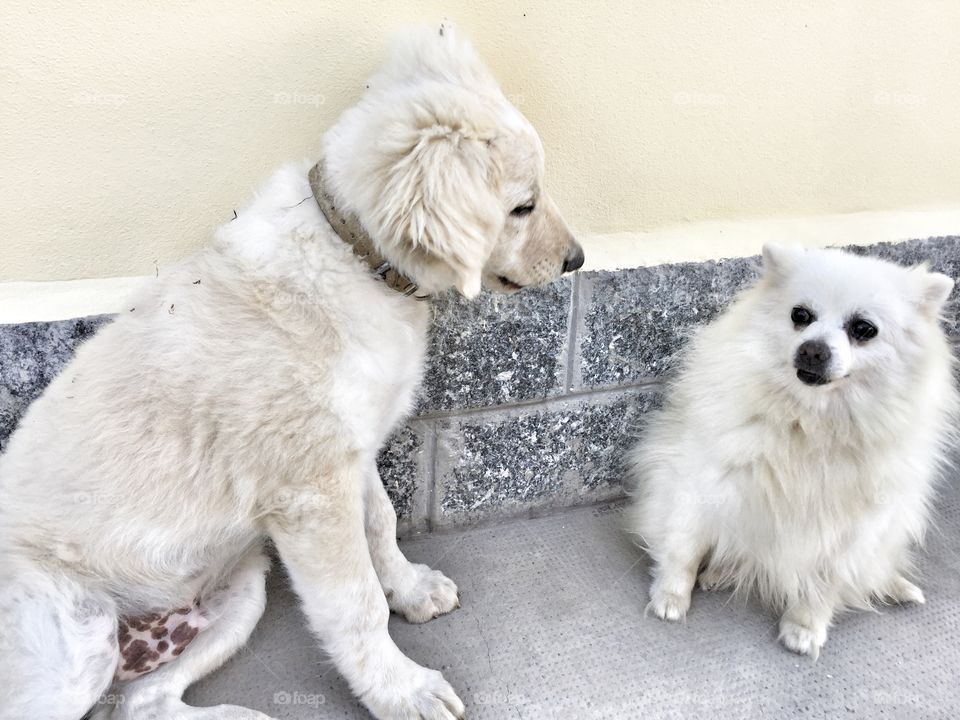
[{"xmin": 0, "ymin": 28, "xmax": 583, "ymax": 720}]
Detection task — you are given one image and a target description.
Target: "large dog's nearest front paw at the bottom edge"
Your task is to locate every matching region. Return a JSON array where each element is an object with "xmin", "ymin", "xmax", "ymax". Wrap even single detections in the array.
[{"xmin": 362, "ymin": 663, "xmax": 466, "ymax": 720}]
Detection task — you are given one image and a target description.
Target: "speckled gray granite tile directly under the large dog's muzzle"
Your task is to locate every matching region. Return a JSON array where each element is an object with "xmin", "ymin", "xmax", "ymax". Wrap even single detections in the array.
[{"xmin": 420, "ymin": 278, "xmax": 572, "ymax": 412}]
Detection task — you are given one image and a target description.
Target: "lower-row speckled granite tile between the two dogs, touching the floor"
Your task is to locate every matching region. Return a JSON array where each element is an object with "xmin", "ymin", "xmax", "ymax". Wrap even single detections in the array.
[{"xmin": 434, "ymin": 389, "xmax": 659, "ymax": 525}]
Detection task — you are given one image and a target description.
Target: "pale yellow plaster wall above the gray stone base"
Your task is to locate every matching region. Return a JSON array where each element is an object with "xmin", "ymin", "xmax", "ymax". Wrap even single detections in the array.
[{"xmin": 0, "ymin": 0, "xmax": 960, "ymax": 281}]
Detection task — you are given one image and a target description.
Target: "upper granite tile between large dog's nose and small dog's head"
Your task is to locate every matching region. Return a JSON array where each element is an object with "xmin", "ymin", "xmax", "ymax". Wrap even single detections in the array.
[{"xmin": 574, "ymin": 258, "xmax": 757, "ymax": 387}]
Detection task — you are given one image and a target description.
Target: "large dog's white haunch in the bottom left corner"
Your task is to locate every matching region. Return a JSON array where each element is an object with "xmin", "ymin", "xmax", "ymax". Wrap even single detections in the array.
[{"xmin": 0, "ymin": 568, "xmax": 119, "ymax": 720}]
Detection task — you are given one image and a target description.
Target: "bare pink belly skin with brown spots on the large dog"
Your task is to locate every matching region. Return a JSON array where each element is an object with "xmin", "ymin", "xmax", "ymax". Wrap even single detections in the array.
[{"xmin": 116, "ymin": 605, "xmax": 210, "ymax": 681}]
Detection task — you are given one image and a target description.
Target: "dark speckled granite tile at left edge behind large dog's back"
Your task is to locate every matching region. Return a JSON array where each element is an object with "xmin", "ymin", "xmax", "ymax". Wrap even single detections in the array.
[{"xmin": 0, "ymin": 315, "xmax": 110, "ymax": 452}]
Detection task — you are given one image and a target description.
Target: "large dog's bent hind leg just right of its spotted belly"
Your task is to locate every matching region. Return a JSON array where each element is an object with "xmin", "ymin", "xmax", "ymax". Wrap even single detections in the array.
[{"xmin": 106, "ymin": 548, "xmax": 278, "ymax": 720}]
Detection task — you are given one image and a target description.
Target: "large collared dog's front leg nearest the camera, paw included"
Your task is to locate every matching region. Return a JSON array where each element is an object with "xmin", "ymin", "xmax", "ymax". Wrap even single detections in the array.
[{"xmin": 267, "ymin": 464, "xmax": 464, "ymax": 720}]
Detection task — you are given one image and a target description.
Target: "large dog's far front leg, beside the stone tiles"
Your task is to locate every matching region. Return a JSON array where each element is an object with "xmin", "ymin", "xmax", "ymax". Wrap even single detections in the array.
[{"xmin": 364, "ymin": 465, "xmax": 460, "ymax": 623}]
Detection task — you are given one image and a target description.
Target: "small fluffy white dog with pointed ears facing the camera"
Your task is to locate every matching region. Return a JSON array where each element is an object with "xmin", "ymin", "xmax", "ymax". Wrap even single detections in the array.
[{"xmin": 630, "ymin": 246, "xmax": 957, "ymax": 657}]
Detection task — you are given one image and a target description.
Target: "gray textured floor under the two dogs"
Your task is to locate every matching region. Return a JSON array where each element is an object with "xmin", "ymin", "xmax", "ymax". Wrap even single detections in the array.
[{"xmin": 187, "ymin": 483, "xmax": 960, "ymax": 720}]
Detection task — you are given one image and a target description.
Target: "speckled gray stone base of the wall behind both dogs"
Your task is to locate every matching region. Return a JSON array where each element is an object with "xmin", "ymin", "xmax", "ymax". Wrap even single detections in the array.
[{"xmin": 0, "ymin": 237, "xmax": 960, "ymax": 532}]
